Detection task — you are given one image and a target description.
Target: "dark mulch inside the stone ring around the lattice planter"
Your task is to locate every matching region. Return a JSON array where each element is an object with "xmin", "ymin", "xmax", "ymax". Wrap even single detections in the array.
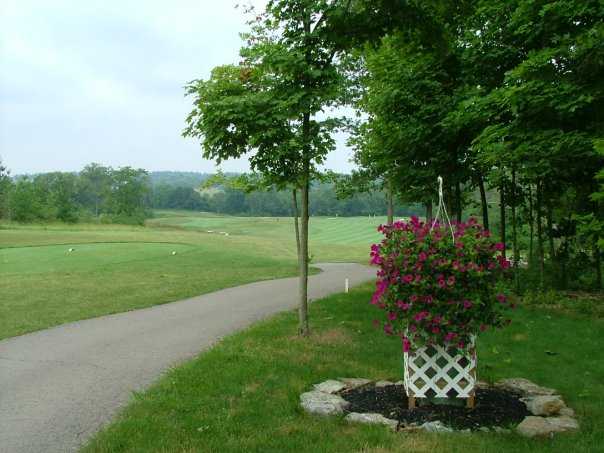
[{"xmin": 341, "ymin": 385, "xmax": 529, "ymax": 430}]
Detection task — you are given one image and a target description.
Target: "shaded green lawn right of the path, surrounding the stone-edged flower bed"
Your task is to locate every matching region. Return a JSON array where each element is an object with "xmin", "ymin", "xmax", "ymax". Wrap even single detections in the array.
[{"xmin": 83, "ymin": 286, "xmax": 604, "ymax": 453}]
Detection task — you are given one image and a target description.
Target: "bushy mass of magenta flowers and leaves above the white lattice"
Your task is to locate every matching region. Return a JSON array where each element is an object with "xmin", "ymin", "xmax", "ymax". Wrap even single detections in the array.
[{"xmin": 371, "ymin": 217, "xmax": 513, "ymax": 351}]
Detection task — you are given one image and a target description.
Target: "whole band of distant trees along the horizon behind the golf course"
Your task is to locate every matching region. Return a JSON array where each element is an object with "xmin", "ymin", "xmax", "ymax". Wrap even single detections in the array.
[{"xmin": 0, "ymin": 163, "xmax": 422, "ymax": 224}]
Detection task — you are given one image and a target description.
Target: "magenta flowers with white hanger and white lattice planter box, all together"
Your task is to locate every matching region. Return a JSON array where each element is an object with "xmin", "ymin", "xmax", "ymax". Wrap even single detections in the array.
[{"xmin": 371, "ymin": 181, "xmax": 513, "ymax": 406}]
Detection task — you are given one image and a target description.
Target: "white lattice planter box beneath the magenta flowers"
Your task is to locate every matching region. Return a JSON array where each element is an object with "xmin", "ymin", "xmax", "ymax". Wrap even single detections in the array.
[{"xmin": 404, "ymin": 345, "xmax": 476, "ymax": 408}]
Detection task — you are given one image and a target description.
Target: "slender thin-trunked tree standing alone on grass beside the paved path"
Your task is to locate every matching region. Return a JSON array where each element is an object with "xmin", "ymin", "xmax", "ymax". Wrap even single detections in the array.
[{"xmin": 184, "ymin": 0, "xmax": 351, "ymax": 335}]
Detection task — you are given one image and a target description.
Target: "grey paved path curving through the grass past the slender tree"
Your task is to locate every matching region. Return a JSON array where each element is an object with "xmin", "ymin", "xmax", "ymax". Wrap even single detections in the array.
[{"xmin": 0, "ymin": 264, "xmax": 375, "ymax": 453}]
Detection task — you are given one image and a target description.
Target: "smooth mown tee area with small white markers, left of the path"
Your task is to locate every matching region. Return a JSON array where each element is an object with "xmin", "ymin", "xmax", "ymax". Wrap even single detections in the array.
[{"xmin": 0, "ymin": 242, "xmax": 194, "ymax": 274}]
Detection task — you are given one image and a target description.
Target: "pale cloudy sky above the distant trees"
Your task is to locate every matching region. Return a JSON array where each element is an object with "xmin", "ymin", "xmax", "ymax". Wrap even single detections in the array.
[{"xmin": 0, "ymin": 0, "xmax": 353, "ymax": 174}]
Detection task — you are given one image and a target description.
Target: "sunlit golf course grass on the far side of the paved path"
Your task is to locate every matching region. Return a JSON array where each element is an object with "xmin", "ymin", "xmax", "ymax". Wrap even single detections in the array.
[{"xmin": 0, "ymin": 211, "xmax": 380, "ymax": 339}]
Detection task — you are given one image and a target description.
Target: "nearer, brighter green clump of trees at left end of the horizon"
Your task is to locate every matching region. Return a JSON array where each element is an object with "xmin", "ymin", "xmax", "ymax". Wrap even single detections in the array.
[{"xmin": 0, "ymin": 163, "xmax": 151, "ymax": 224}]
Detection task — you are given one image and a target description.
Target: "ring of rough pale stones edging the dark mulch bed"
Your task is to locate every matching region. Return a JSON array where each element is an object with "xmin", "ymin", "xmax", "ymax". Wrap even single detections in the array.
[{"xmin": 300, "ymin": 378, "xmax": 579, "ymax": 437}]
